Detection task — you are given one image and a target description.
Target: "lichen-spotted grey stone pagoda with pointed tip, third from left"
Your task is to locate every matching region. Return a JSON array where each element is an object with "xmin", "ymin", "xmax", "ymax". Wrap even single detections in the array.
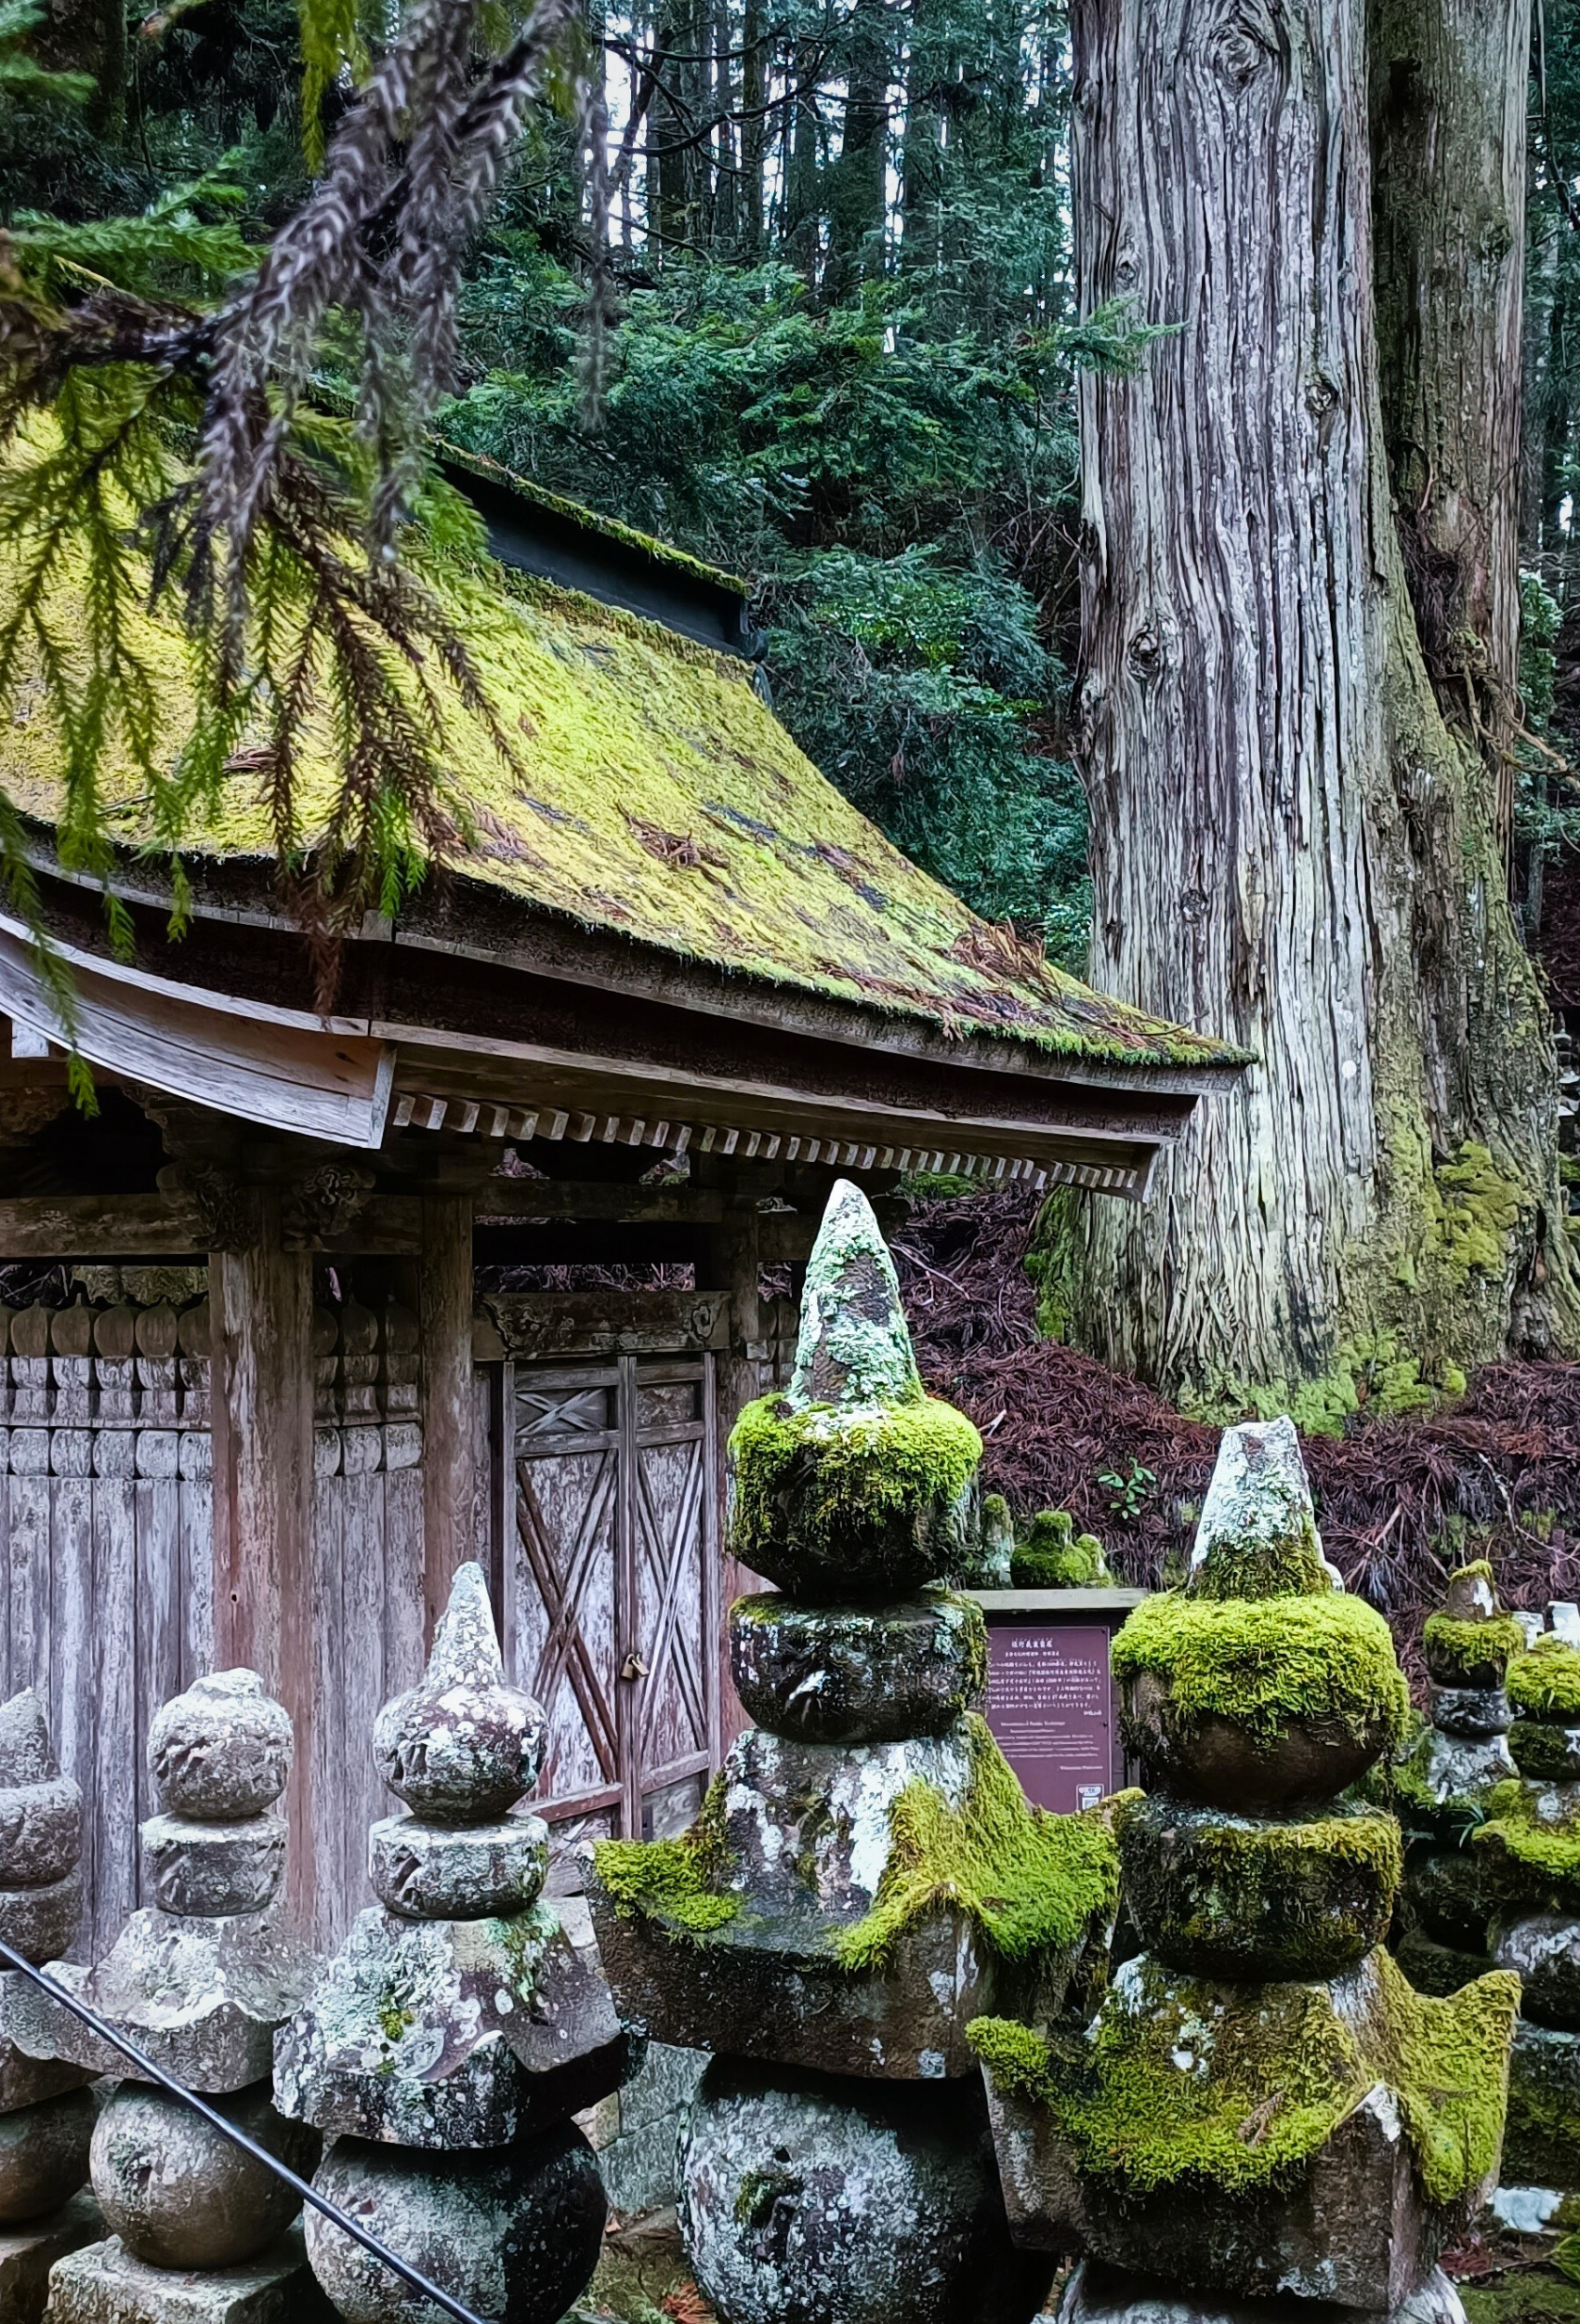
[{"xmin": 274, "ymin": 1566, "xmax": 641, "ymax": 2324}]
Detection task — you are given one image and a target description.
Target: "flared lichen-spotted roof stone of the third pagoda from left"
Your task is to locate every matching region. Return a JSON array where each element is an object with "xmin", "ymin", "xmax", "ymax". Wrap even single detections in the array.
[{"xmin": 274, "ymin": 1899, "xmax": 641, "ymax": 2147}]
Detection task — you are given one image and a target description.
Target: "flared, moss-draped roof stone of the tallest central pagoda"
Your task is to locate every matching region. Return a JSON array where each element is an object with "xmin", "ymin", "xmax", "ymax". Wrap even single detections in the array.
[{"xmin": 588, "ymin": 1720, "xmax": 1113, "ymax": 2080}]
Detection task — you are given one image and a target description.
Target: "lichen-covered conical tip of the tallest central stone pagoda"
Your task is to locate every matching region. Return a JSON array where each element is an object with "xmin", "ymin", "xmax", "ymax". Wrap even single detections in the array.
[{"xmin": 788, "ymin": 1179, "xmax": 923, "ymax": 1411}]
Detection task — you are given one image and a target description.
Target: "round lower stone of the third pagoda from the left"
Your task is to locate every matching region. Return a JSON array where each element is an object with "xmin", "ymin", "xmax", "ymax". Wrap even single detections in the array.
[{"xmin": 305, "ymin": 2122, "xmax": 609, "ymax": 2324}]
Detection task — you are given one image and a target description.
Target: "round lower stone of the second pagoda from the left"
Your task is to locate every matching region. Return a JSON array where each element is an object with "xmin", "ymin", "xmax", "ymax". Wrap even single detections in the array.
[{"xmin": 93, "ymin": 2082, "xmax": 323, "ymax": 2268}]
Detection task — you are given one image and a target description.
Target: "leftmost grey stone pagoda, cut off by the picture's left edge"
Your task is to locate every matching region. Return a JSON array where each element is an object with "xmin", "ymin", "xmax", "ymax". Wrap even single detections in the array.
[{"xmin": 0, "ymin": 1692, "xmax": 105, "ymax": 2324}]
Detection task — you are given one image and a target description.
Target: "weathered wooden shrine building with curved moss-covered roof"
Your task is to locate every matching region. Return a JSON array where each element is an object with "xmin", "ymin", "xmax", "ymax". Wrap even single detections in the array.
[{"xmin": 0, "ymin": 474, "xmax": 1239, "ymax": 1948}]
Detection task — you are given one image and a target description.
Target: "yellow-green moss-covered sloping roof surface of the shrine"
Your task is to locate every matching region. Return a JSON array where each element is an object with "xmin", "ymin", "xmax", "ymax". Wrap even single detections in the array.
[{"xmin": 0, "ymin": 508, "xmax": 1236, "ymax": 1067}]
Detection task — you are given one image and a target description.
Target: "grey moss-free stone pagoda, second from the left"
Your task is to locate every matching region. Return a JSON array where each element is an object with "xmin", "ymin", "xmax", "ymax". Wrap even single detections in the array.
[{"xmin": 7, "ymin": 1671, "xmax": 325, "ymax": 2324}]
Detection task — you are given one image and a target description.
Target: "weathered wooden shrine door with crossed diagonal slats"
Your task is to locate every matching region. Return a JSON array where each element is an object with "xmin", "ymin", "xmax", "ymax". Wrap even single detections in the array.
[{"xmin": 505, "ymin": 1355, "xmax": 720, "ymax": 1853}]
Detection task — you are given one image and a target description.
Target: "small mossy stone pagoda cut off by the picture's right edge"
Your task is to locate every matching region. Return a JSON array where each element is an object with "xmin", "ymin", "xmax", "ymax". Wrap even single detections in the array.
[{"xmin": 1473, "ymin": 1608, "xmax": 1580, "ymax": 2226}]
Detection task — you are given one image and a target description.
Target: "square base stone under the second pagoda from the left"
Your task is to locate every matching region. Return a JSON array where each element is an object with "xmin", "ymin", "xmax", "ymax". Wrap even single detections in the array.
[{"xmin": 43, "ymin": 2229, "xmax": 337, "ymax": 2324}]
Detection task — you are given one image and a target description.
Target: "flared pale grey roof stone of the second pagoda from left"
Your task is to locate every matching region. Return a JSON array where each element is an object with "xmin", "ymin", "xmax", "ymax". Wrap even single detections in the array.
[{"xmin": 0, "ymin": 1910, "xmax": 319, "ymax": 2094}]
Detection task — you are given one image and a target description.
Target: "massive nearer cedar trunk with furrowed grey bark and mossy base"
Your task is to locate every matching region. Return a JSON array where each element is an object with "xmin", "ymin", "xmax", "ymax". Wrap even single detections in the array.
[{"xmin": 1044, "ymin": 0, "xmax": 1575, "ymax": 1416}]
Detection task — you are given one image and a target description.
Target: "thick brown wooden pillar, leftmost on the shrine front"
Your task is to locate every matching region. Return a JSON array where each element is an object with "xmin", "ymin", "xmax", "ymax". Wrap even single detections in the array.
[{"xmin": 209, "ymin": 1218, "xmax": 316, "ymax": 1929}]
